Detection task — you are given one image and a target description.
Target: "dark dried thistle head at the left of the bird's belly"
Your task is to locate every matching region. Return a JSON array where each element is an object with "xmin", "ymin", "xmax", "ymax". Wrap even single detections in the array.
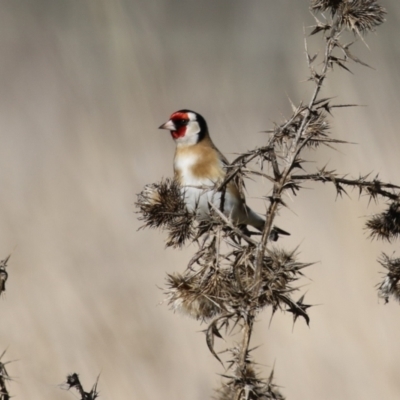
[{"xmin": 136, "ymin": 179, "xmax": 195, "ymax": 247}]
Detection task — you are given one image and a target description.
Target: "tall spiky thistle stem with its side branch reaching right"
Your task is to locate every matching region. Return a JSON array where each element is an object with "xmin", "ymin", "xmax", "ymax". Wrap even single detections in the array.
[{"xmin": 227, "ymin": 1, "xmax": 390, "ymax": 390}]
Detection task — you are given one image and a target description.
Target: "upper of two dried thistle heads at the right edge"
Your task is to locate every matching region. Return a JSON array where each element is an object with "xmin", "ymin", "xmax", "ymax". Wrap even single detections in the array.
[{"xmin": 366, "ymin": 200, "xmax": 400, "ymax": 242}]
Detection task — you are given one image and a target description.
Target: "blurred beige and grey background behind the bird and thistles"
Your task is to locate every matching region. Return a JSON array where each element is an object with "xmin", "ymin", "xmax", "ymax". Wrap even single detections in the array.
[{"xmin": 0, "ymin": 0, "xmax": 400, "ymax": 400}]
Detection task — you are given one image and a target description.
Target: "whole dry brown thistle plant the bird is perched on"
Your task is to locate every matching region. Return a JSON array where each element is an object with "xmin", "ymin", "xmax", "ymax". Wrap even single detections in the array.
[{"xmin": 137, "ymin": 0, "xmax": 400, "ymax": 400}]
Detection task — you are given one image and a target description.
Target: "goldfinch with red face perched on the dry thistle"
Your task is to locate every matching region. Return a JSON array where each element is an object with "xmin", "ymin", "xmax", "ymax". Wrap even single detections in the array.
[{"xmin": 159, "ymin": 109, "xmax": 290, "ymax": 241}]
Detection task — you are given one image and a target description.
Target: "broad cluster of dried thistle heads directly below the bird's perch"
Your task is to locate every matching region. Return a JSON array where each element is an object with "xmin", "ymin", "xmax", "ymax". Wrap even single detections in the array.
[{"xmin": 166, "ymin": 245, "xmax": 310, "ymax": 323}]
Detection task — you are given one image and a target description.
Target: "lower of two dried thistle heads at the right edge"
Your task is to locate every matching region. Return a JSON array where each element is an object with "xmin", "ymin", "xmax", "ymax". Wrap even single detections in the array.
[{"xmin": 378, "ymin": 253, "xmax": 400, "ymax": 303}]
